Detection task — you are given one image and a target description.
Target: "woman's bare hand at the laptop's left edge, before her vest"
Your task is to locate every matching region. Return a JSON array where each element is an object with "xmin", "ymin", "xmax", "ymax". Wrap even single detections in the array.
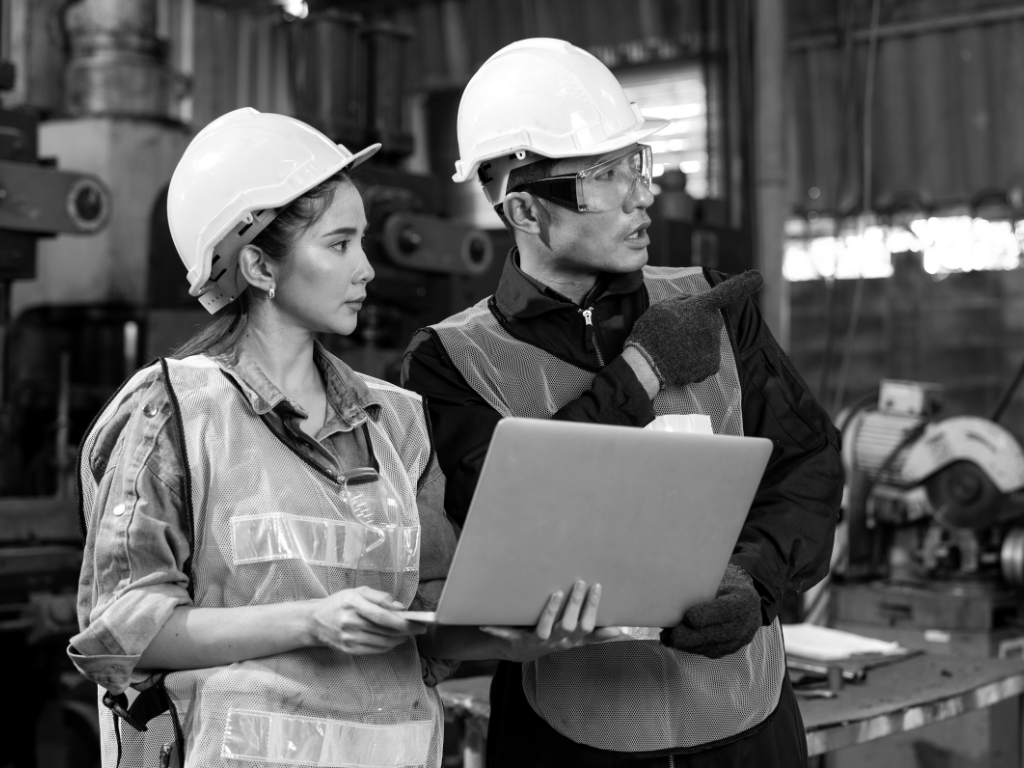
[{"xmin": 311, "ymin": 587, "xmax": 426, "ymax": 654}]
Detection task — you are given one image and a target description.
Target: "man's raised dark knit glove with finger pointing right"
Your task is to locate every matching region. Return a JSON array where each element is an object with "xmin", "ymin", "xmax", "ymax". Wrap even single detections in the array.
[{"xmin": 626, "ymin": 269, "xmax": 764, "ymax": 387}]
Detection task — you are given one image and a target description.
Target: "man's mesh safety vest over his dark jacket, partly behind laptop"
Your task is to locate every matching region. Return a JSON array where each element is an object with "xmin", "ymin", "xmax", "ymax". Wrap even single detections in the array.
[{"xmin": 432, "ymin": 267, "xmax": 785, "ymax": 752}]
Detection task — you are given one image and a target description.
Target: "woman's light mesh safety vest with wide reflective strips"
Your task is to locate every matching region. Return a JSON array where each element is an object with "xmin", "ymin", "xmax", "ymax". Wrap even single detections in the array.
[{"xmin": 80, "ymin": 356, "xmax": 441, "ymax": 768}]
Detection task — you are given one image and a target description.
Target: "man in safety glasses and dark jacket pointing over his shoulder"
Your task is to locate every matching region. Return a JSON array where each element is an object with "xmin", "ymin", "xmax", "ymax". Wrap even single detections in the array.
[{"xmin": 402, "ymin": 39, "xmax": 842, "ymax": 768}]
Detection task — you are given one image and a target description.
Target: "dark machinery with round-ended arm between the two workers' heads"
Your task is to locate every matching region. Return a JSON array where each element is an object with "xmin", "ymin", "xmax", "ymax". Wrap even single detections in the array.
[{"xmin": 290, "ymin": 10, "xmax": 500, "ymax": 379}]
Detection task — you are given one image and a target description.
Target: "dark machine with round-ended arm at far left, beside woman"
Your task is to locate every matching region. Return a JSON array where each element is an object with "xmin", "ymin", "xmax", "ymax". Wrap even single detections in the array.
[{"xmin": 0, "ymin": 62, "xmax": 111, "ymax": 766}]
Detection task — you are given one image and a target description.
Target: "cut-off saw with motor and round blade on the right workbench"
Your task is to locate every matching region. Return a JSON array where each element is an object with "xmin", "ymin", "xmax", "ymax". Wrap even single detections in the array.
[{"xmin": 831, "ymin": 381, "xmax": 1024, "ymax": 655}]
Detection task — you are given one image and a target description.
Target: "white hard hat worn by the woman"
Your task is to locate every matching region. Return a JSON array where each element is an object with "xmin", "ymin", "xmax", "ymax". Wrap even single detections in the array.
[{"xmin": 167, "ymin": 106, "xmax": 381, "ymax": 314}]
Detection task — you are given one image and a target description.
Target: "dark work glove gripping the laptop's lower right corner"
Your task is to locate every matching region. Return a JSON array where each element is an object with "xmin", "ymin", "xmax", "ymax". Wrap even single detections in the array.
[{"xmin": 662, "ymin": 563, "xmax": 761, "ymax": 658}]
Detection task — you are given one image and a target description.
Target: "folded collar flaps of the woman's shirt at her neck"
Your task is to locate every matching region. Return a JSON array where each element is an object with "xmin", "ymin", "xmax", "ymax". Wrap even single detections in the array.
[{"xmin": 214, "ymin": 341, "xmax": 381, "ymax": 428}]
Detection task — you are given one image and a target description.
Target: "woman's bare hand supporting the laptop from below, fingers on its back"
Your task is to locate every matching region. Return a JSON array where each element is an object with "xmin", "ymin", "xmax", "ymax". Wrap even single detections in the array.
[{"xmin": 480, "ymin": 581, "xmax": 622, "ymax": 662}]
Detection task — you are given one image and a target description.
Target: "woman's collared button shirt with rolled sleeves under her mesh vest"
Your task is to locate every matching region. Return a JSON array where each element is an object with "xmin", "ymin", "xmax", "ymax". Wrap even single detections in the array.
[{"xmin": 69, "ymin": 344, "xmax": 456, "ymax": 692}]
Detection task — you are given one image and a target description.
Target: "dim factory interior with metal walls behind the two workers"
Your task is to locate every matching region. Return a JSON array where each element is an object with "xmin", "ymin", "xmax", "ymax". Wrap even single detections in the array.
[{"xmin": 6, "ymin": 0, "xmax": 1024, "ymax": 768}]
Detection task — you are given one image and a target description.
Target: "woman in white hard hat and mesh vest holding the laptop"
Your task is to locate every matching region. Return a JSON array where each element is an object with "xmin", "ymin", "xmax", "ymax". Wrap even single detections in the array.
[{"xmin": 69, "ymin": 109, "xmax": 614, "ymax": 768}]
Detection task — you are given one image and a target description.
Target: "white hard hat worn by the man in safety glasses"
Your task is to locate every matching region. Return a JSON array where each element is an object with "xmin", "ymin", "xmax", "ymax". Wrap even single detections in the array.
[{"xmin": 452, "ymin": 38, "xmax": 669, "ymax": 205}]
